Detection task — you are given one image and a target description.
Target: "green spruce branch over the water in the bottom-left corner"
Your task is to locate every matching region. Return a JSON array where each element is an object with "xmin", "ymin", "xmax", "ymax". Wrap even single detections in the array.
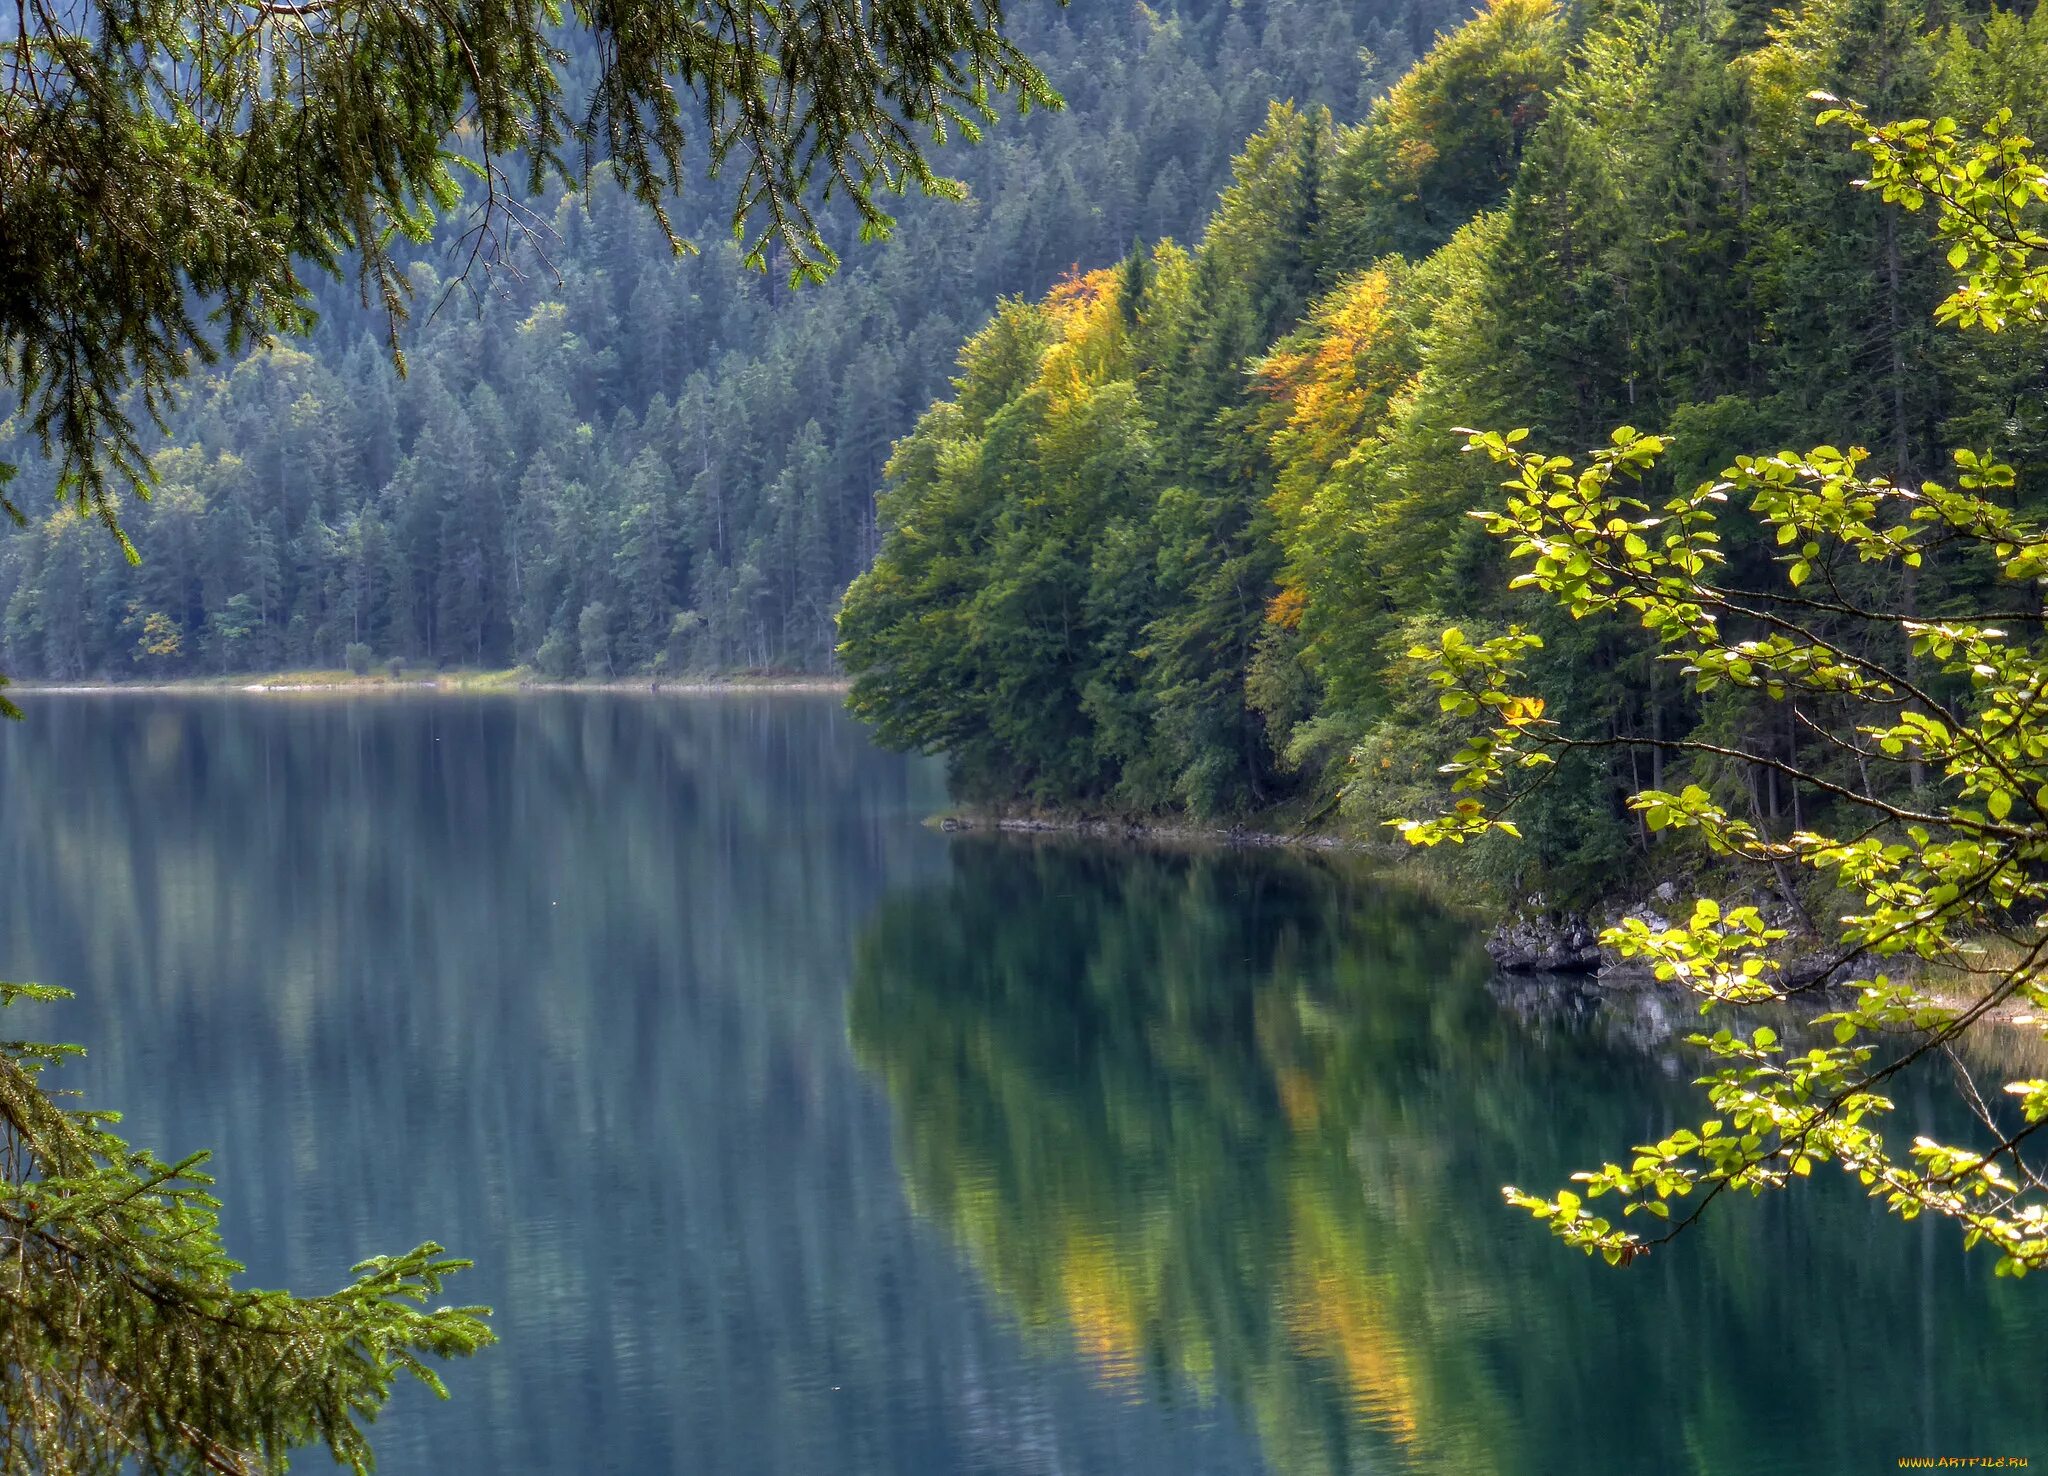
[{"xmin": 0, "ymin": 985, "xmax": 492, "ymax": 1476}]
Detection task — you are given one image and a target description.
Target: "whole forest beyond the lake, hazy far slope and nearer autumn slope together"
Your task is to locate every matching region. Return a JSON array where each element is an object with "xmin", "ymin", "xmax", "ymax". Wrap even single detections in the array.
[{"xmin": 12, "ymin": 0, "xmax": 2048, "ymax": 899}]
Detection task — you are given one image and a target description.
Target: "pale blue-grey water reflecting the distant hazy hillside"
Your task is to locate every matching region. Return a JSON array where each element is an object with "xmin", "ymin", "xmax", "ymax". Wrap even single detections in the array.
[{"xmin": 0, "ymin": 696, "xmax": 1253, "ymax": 1476}]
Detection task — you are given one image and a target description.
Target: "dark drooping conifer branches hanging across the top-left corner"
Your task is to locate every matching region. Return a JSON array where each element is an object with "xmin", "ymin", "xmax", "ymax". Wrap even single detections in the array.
[{"xmin": 0, "ymin": 0, "xmax": 1059, "ymax": 540}]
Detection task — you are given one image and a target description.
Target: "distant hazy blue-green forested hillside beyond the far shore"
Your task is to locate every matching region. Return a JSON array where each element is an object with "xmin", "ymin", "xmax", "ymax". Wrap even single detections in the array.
[{"xmin": 0, "ymin": 0, "xmax": 1462, "ymax": 680}]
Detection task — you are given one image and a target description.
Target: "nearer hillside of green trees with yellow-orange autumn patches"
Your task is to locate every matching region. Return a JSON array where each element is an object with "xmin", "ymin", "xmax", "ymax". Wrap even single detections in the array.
[{"xmin": 842, "ymin": 0, "xmax": 2048, "ymax": 895}]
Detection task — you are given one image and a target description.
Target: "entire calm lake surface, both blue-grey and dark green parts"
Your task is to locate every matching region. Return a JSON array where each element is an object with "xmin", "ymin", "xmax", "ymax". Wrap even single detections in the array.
[{"xmin": 0, "ymin": 694, "xmax": 2048, "ymax": 1476}]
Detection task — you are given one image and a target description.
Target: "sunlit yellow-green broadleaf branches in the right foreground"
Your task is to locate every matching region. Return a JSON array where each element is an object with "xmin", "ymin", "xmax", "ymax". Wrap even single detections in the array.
[{"xmin": 1401, "ymin": 98, "xmax": 2048, "ymax": 1275}]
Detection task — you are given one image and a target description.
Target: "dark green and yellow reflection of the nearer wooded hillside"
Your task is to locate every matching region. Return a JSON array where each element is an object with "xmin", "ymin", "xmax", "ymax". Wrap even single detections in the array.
[{"xmin": 850, "ymin": 839, "xmax": 2048, "ymax": 1476}]
